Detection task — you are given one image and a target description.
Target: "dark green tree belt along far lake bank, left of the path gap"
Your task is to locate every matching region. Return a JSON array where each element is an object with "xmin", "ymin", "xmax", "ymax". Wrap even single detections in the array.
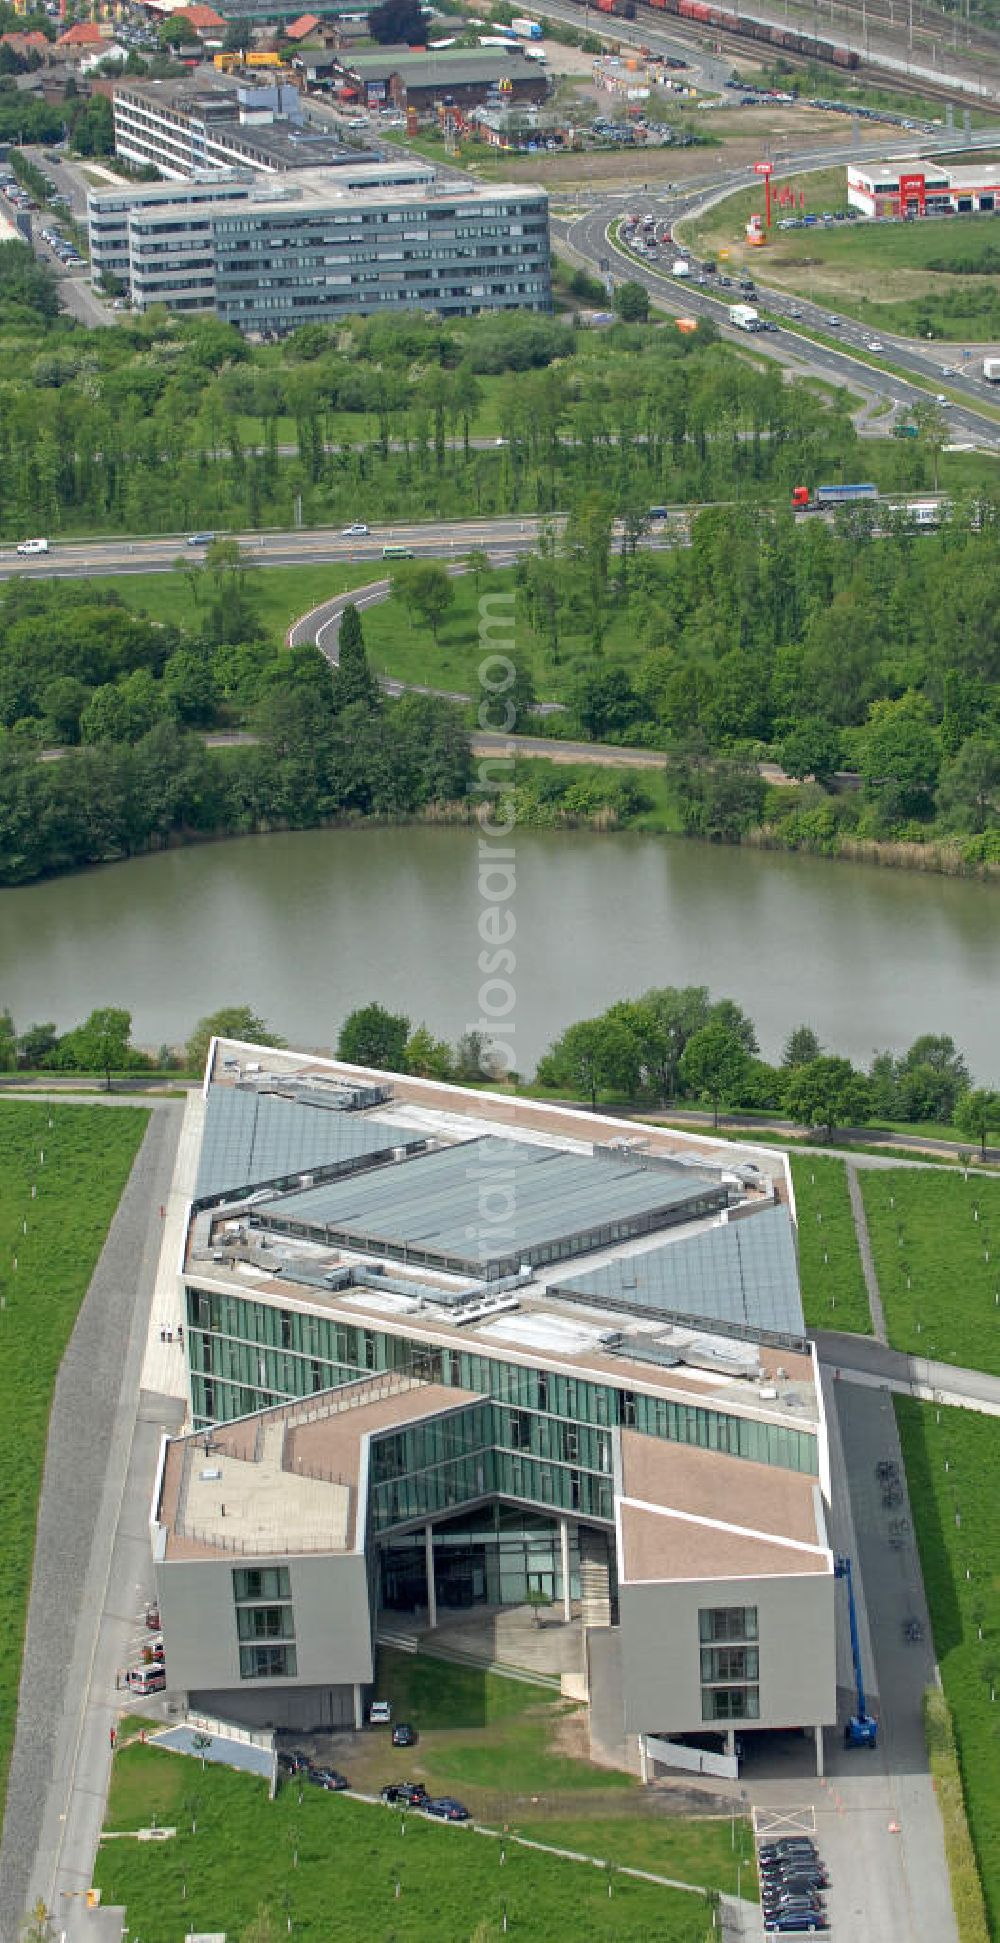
[{"xmin": 0, "ymin": 608, "xmax": 472, "ymax": 884}]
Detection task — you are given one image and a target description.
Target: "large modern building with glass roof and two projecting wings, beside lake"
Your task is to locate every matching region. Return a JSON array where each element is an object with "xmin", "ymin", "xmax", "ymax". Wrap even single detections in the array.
[{"xmin": 153, "ymin": 1047, "xmax": 837, "ymax": 1779}]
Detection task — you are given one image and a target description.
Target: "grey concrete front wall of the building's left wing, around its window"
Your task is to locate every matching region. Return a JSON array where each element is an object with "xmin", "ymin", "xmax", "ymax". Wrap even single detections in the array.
[{"xmin": 155, "ymin": 1552, "xmax": 373, "ymax": 1694}]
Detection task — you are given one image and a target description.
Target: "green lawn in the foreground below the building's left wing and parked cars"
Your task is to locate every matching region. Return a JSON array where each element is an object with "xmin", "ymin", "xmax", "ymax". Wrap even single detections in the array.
[{"xmin": 95, "ymin": 1743, "xmax": 711, "ymax": 1943}]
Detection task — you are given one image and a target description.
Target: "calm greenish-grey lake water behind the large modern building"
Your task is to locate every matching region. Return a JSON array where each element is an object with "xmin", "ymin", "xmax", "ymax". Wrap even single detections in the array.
[{"xmin": 0, "ymin": 826, "xmax": 1000, "ymax": 1082}]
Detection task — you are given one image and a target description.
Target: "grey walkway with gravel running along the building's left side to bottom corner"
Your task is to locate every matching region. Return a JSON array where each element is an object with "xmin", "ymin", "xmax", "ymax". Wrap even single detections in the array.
[{"xmin": 0, "ymin": 1106, "xmax": 181, "ymax": 1943}]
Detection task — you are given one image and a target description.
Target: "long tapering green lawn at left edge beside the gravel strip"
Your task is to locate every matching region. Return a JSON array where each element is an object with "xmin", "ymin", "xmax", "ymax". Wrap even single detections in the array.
[{"xmin": 0, "ymin": 1100, "xmax": 150, "ymax": 1807}]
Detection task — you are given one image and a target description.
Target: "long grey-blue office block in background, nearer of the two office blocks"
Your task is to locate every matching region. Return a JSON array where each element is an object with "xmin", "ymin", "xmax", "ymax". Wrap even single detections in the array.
[{"xmin": 87, "ymin": 161, "xmax": 551, "ymax": 324}]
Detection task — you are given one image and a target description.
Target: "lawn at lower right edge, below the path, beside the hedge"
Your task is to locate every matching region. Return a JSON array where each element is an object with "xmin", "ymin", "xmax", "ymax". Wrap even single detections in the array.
[{"xmin": 895, "ymin": 1397, "xmax": 1000, "ymax": 1943}]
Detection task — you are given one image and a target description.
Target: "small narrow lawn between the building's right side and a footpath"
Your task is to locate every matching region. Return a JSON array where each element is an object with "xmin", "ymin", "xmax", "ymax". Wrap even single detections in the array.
[{"xmin": 792, "ymin": 1154, "xmax": 872, "ymax": 1335}]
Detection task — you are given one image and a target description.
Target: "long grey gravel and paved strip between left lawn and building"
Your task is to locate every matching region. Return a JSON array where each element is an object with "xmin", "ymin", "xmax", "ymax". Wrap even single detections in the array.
[{"xmin": 0, "ymin": 1102, "xmax": 183, "ymax": 1943}]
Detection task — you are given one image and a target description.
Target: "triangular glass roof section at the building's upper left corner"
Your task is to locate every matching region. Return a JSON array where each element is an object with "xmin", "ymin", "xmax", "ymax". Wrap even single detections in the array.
[{"xmin": 194, "ymin": 1086, "xmax": 409, "ymax": 1201}]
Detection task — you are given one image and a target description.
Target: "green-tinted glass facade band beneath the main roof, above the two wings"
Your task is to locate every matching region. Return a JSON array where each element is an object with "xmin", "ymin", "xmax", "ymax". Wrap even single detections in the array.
[{"xmin": 186, "ymin": 1288, "xmax": 819, "ymax": 1468}]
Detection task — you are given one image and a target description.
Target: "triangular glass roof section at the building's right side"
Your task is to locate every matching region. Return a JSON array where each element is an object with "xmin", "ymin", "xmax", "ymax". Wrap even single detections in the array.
[{"xmin": 551, "ymin": 1205, "xmax": 806, "ymax": 1337}]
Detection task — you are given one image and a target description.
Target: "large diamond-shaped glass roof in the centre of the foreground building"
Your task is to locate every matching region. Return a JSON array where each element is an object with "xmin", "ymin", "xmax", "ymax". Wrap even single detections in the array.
[{"xmin": 262, "ymin": 1135, "xmax": 728, "ymax": 1269}]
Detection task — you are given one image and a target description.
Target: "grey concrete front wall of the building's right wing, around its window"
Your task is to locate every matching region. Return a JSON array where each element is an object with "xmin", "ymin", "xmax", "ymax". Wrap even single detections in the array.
[{"xmin": 617, "ymin": 1572, "xmax": 837, "ymax": 1735}]
